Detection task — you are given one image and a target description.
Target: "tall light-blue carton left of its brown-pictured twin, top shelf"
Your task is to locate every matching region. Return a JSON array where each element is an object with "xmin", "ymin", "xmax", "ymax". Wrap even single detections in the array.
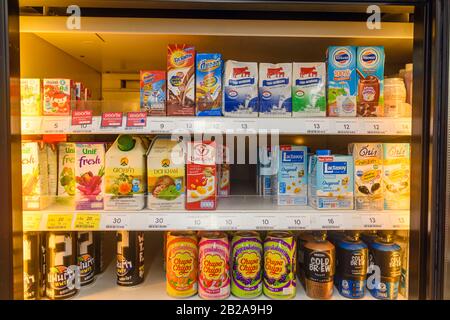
[{"xmin": 327, "ymin": 46, "xmax": 358, "ymax": 117}]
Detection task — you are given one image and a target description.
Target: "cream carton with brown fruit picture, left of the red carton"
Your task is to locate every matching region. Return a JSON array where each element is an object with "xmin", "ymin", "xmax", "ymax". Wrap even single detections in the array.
[{"xmin": 147, "ymin": 136, "xmax": 186, "ymax": 210}]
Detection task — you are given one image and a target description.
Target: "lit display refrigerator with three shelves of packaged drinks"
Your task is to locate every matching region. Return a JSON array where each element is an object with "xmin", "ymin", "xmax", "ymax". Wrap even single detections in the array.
[{"xmin": 0, "ymin": 0, "xmax": 441, "ymax": 299}]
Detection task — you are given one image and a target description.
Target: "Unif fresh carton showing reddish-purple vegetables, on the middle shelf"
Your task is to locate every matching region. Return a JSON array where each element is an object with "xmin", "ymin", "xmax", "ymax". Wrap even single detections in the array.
[{"xmin": 75, "ymin": 143, "xmax": 105, "ymax": 210}]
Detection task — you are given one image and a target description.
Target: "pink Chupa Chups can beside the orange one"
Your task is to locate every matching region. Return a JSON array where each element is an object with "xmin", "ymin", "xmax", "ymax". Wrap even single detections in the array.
[{"xmin": 198, "ymin": 232, "xmax": 230, "ymax": 300}]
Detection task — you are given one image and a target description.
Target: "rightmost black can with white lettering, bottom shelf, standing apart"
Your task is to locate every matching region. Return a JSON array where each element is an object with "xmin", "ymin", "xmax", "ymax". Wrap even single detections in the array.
[{"xmin": 116, "ymin": 231, "xmax": 144, "ymax": 287}]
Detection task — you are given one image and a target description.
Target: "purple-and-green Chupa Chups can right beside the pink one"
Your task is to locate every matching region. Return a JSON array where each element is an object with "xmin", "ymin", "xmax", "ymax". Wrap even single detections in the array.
[{"xmin": 231, "ymin": 231, "xmax": 263, "ymax": 299}]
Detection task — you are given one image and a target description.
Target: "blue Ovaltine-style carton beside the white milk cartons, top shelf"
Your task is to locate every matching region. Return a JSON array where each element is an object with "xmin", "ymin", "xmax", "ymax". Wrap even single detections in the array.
[{"xmin": 195, "ymin": 53, "xmax": 223, "ymax": 116}]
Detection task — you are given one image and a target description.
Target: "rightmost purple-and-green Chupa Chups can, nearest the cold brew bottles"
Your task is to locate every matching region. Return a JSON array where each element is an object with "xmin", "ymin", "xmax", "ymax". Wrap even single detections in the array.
[{"xmin": 263, "ymin": 232, "xmax": 297, "ymax": 299}]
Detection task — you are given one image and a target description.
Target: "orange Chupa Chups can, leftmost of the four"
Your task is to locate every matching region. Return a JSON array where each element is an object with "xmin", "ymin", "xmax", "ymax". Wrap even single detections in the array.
[{"xmin": 166, "ymin": 231, "xmax": 198, "ymax": 298}]
